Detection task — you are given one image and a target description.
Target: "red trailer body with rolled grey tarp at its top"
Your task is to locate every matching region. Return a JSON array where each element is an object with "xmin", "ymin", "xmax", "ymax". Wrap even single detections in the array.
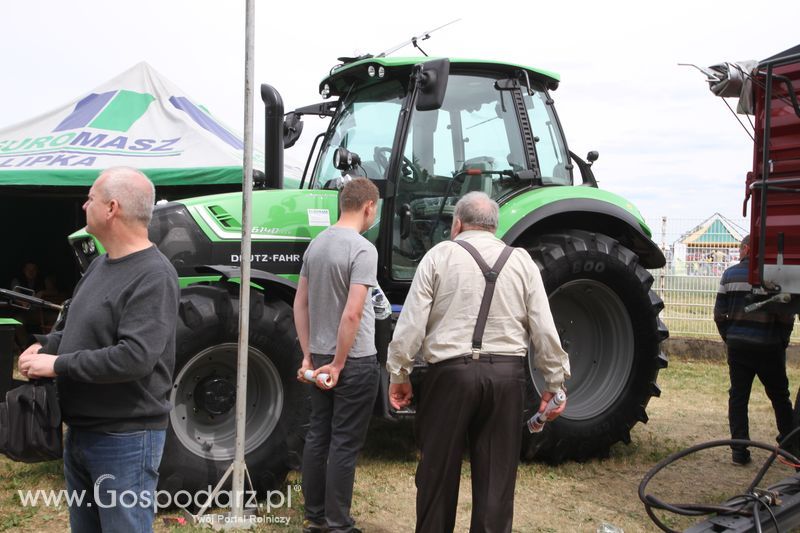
[{"xmin": 704, "ymin": 45, "xmax": 800, "ymax": 312}]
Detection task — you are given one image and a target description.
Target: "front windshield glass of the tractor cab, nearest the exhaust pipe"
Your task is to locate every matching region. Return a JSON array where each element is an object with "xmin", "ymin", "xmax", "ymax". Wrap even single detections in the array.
[{"xmin": 312, "ymin": 79, "xmax": 404, "ymax": 188}]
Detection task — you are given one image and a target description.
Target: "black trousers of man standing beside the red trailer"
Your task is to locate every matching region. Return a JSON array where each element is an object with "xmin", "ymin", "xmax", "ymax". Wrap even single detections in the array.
[{"xmin": 728, "ymin": 347, "xmax": 794, "ymax": 452}]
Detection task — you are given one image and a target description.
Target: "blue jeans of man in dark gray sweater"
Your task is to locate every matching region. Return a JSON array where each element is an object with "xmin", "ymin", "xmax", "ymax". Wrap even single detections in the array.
[{"xmin": 64, "ymin": 428, "xmax": 166, "ymax": 533}]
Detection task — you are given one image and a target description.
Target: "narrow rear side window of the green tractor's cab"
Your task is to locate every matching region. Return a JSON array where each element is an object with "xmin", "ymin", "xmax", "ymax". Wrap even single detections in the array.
[{"xmin": 525, "ymin": 91, "xmax": 572, "ymax": 185}]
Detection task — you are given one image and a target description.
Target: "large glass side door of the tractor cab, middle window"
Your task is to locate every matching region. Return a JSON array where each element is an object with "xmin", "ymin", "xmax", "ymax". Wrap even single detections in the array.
[{"xmin": 392, "ymin": 74, "xmax": 530, "ymax": 279}]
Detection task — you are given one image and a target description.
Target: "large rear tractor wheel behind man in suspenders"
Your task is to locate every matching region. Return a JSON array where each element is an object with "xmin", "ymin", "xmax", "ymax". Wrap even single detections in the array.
[{"xmin": 522, "ymin": 230, "xmax": 668, "ymax": 462}]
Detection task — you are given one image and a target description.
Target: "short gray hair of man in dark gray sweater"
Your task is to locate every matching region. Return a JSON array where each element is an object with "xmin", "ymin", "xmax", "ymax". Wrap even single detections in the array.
[{"xmin": 100, "ymin": 167, "xmax": 156, "ymax": 227}]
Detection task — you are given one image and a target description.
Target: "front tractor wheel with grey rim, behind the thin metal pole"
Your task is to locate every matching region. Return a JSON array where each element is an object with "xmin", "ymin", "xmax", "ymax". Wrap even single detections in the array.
[{"xmin": 159, "ymin": 284, "xmax": 309, "ymax": 498}]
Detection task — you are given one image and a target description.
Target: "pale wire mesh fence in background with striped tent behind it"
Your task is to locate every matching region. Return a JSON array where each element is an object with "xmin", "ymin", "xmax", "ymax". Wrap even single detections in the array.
[{"xmin": 647, "ymin": 213, "xmax": 800, "ymax": 342}]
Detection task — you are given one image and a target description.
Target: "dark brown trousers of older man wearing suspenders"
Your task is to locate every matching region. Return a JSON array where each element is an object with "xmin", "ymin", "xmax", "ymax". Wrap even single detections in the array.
[{"xmin": 416, "ymin": 356, "xmax": 526, "ymax": 533}]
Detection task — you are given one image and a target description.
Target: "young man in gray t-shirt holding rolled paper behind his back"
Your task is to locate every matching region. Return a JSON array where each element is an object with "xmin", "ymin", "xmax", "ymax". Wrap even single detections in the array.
[{"xmin": 294, "ymin": 178, "xmax": 379, "ymax": 532}]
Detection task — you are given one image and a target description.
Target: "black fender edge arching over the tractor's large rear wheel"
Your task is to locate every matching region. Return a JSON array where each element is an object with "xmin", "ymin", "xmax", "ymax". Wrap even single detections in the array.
[{"xmin": 501, "ymin": 198, "xmax": 666, "ymax": 268}]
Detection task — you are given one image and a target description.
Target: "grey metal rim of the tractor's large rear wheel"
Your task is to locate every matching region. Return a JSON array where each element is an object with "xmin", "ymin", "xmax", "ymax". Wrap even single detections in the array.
[{"xmin": 533, "ymin": 279, "xmax": 634, "ymax": 420}]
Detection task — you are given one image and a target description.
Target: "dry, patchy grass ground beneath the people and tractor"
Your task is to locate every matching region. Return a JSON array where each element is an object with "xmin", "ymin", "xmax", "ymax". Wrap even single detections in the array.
[{"xmin": 0, "ymin": 360, "xmax": 800, "ymax": 533}]
